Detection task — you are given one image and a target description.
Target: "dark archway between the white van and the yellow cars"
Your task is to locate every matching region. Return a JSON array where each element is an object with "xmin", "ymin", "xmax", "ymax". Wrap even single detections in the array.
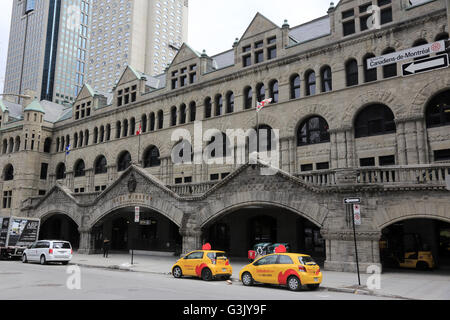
[{"xmin": 92, "ymin": 206, "xmax": 182, "ymax": 253}]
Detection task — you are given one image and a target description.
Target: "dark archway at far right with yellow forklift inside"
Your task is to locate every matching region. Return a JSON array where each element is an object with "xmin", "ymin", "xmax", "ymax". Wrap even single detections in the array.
[{"xmin": 380, "ymin": 218, "xmax": 450, "ymax": 271}]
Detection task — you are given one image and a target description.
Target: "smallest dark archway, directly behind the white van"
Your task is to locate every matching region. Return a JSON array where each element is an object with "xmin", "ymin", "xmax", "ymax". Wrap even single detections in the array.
[{"xmin": 39, "ymin": 214, "xmax": 80, "ymax": 249}]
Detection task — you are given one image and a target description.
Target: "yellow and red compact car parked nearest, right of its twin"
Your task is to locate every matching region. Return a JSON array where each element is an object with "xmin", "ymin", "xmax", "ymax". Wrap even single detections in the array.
[{"xmin": 239, "ymin": 253, "xmax": 322, "ymax": 291}]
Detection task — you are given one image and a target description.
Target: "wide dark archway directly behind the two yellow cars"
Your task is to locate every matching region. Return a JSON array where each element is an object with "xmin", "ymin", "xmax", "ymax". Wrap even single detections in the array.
[{"xmin": 202, "ymin": 204, "xmax": 325, "ymax": 263}]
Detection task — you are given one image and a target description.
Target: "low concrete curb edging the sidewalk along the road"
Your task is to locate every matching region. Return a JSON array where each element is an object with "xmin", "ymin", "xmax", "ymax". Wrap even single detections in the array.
[{"xmin": 73, "ymin": 263, "xmax": 418, "ymax": 300}]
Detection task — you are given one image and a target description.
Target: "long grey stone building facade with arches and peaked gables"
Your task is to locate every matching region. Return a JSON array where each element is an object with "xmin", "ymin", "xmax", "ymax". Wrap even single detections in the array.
[{"xmin": 0, "ymin": 0, "xmax": 450, "ymax": 270}]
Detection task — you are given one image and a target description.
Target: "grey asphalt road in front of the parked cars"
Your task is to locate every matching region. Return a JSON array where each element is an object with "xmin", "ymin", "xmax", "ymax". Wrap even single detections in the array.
[{"xmin": 0, "ymin": 261, "xmax": 394, "ymax": 301}]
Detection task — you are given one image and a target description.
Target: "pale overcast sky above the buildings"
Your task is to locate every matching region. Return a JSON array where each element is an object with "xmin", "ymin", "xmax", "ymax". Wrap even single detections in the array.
[{"xmin": 0, "ymin": 0, "xmax": 330, "ymax": 92}]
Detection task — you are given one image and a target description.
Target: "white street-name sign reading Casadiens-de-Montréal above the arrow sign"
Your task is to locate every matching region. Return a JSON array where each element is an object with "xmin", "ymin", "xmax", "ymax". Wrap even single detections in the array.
[{"xmin": 367, "ymin": 40, "xmax": 445, "ymax": 69}]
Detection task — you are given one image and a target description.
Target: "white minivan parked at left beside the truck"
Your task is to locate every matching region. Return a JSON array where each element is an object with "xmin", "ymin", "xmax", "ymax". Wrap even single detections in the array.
[{"xmin": 22, "ymin": 240, "xmax": 73, "ymax": 265}]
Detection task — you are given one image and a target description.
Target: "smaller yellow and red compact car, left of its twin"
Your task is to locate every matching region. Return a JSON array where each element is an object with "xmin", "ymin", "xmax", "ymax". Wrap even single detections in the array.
[{"xmin": 172, "ymin": 250, "xmax": 233, "ymax": 281}]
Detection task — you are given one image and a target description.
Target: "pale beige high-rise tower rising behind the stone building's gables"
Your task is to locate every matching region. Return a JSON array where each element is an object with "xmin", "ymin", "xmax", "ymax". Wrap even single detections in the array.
[{"xmin": 87, "ymin": 0, "xmax": 189, "ymax": 92}]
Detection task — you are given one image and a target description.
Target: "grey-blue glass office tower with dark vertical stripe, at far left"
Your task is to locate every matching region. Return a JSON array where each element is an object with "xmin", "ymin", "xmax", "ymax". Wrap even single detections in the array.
[{"xmin": 3, "ymin": 0, "xmax": 90, "ymax": 103}]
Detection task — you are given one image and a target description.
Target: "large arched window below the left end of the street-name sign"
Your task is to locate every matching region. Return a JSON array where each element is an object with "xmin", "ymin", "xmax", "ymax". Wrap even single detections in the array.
[{"xmin": 355, "ymin": 104, "xmax": 396, "ymax": 138}]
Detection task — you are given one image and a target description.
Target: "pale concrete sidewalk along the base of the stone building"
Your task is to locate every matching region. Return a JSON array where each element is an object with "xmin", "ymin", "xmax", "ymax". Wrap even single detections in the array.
[{"xmin": 71, "ymin": 253, "xmax": 450, "ymax": 300}]
